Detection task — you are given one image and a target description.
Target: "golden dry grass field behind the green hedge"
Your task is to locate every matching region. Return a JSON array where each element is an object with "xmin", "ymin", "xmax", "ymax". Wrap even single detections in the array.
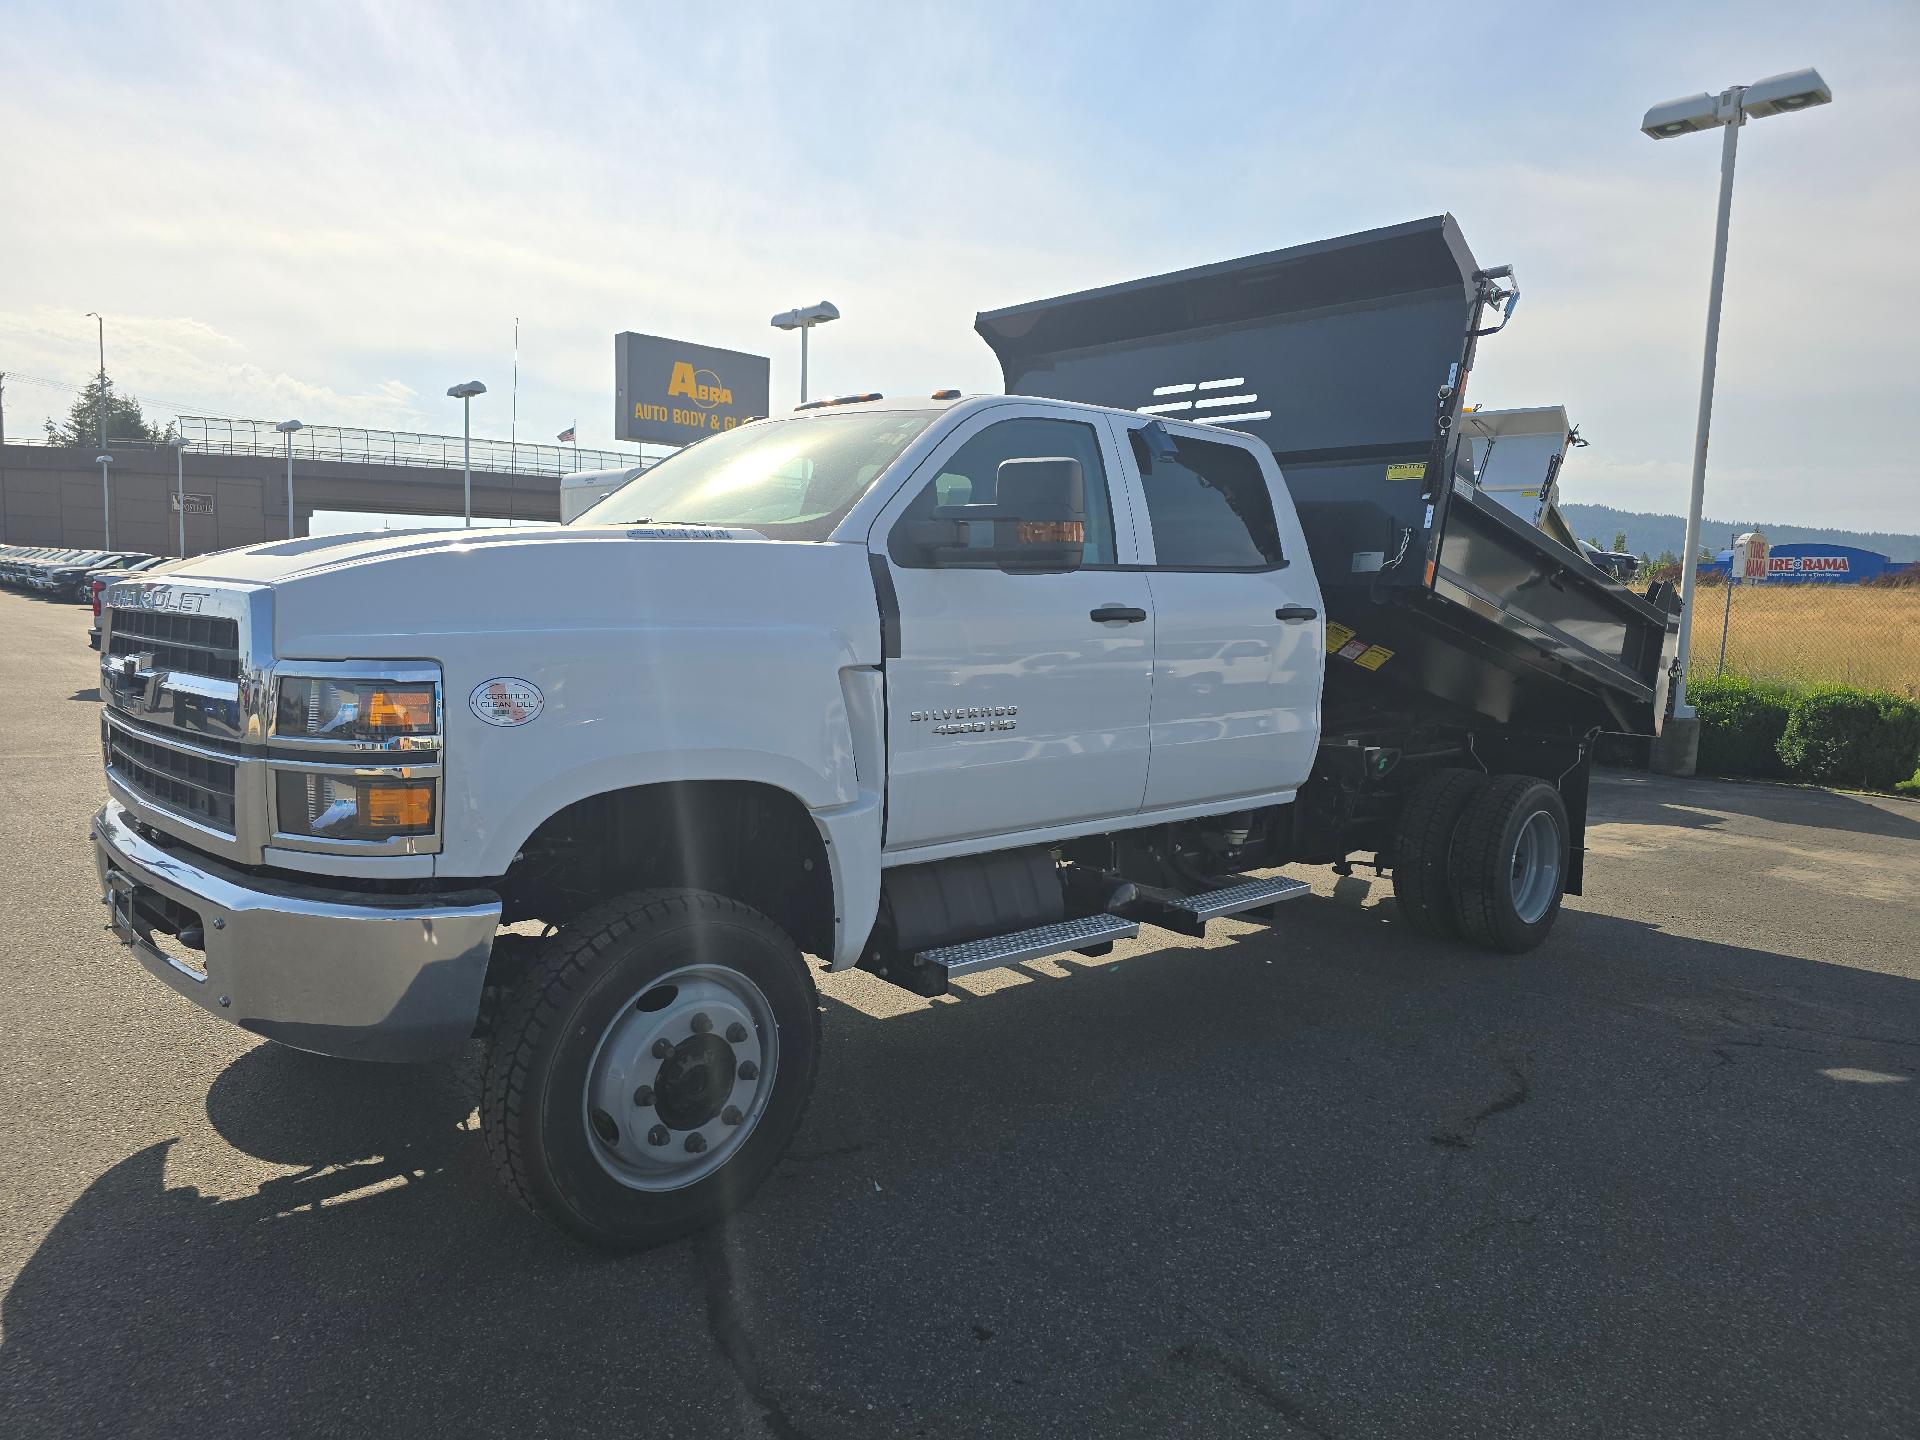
[{"xmin": 1692, "ymin": 584, "xmax": 1920, "ymax": 699}]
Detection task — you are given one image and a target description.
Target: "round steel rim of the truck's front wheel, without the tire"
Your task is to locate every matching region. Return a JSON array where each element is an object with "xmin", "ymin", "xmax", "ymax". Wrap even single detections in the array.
[{"xmin": 582, "ymin": 964, "xmax": 780, "ymax": 1190}]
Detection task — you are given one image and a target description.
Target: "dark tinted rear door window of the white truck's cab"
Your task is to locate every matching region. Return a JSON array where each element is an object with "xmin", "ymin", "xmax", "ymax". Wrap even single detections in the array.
[{"xmin": 1135, "ymin": 436, "xmax": 1284, "ymax": 570}]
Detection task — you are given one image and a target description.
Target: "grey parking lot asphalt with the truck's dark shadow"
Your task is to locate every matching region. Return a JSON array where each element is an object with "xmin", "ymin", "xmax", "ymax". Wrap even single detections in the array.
[{"xmin": 0, "ymin": 593, "xmax": 1920, "ymax": 1440}]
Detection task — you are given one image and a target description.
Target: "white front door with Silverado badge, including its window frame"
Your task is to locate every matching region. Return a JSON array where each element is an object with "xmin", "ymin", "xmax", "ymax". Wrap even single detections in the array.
[{"xmin": 874, "ymin": 405, "xmax": 1154, "ymax": 854}]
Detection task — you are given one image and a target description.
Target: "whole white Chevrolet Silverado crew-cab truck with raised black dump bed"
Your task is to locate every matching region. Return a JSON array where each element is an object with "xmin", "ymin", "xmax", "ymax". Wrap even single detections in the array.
[{"xmin": 92, "ymin": 219, "xmax": 1670, "ymax": 1246}]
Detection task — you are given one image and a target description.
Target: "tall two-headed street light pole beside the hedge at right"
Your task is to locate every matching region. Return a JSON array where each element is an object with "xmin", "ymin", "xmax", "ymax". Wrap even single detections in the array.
[{"xmin": 1640, "ymin": 69, "xmax": 1834, "ymax": 720}]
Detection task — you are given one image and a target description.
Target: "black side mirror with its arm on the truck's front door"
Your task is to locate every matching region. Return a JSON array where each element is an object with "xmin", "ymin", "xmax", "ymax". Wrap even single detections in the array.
[{"xmin": 908, "ymin": 457, "xmax": 1087, "ymax": 570}]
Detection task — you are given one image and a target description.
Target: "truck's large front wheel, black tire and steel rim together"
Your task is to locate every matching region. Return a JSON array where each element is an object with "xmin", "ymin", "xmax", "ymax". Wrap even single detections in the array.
[{"xmin": 480, "ymin": 891, "xmax": 820, "ymax": 1250}]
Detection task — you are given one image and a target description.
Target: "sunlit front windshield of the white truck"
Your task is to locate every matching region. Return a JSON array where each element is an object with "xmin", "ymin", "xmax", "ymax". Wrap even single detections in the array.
[{"xmin": 570, "ymin": 411, "xmax": 945, "ymax": 540}]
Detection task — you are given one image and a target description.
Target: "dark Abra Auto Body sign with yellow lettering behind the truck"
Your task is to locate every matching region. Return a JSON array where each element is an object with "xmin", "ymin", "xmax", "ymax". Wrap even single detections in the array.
[{"xmin": 612, "ymin": 330, "xmax": 768, "ymax": 445}]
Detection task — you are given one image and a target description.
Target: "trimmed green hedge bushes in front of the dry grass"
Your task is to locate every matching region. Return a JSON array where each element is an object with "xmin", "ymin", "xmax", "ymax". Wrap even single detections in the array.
[{"xmin": 1688, "ymin": 676, "xmax": 1920, "ymax": 789}]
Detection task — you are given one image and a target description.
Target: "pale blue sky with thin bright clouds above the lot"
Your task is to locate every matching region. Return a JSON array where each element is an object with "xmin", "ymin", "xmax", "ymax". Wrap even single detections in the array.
[{"xmin": 0, "ymin": 0, "xmax": 1920, "ymax": 532}]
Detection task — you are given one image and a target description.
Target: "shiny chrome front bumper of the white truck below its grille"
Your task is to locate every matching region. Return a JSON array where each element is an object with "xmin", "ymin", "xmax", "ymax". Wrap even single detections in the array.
[{"xmin": 92, "ymin": 801, "xmax": 499, "ymax": 1060}]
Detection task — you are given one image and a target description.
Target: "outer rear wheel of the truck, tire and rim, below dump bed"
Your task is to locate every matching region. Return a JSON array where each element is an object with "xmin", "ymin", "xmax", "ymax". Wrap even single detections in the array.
[{"xmin": 1450, "ymin": 776, "xmax": 1569, "ymax": 954}]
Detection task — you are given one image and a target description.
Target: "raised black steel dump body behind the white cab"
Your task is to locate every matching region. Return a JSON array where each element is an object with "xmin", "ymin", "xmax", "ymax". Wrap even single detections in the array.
[{"xmin": 975, "ymin": 215, "xmax": 1670, "ymax": 737}]
